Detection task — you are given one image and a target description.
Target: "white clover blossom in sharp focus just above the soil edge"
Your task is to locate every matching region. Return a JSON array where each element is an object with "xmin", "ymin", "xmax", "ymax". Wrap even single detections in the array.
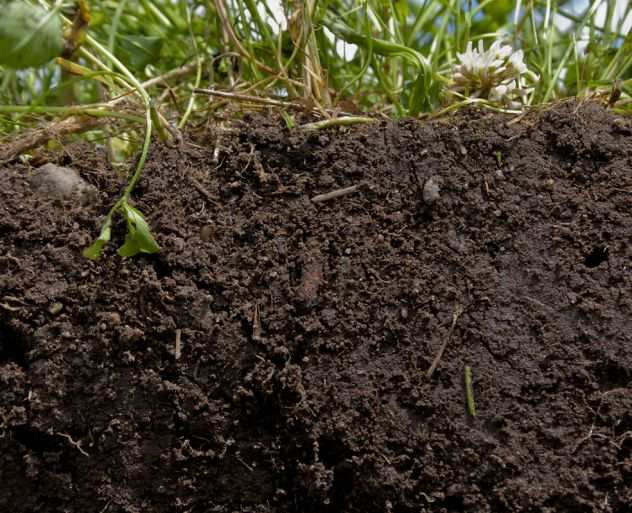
[{"xmin": 452, "ymin": 40, "xmax": 538, "ymax": 108}]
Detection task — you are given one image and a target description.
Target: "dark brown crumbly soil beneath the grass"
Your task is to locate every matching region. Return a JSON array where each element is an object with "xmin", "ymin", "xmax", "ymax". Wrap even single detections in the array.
[{"xmin": 0, "ymin": 103, "xmax": 632, "ymax": 513}]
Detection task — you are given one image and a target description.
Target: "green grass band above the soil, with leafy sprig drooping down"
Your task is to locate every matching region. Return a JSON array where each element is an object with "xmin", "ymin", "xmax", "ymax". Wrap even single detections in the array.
[{"xmin": 0, "ymin": 0, "xmax": 632, "ymax": 258}]
